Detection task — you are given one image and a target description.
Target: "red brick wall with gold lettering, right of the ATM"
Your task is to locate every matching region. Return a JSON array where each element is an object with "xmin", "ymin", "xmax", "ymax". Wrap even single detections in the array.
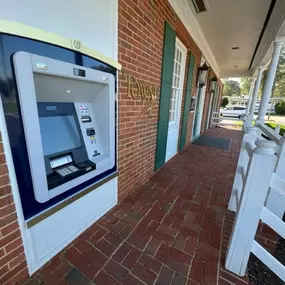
[{"xmin": 119, "ymin": 0, "xmax": 201, "ymax": 199}]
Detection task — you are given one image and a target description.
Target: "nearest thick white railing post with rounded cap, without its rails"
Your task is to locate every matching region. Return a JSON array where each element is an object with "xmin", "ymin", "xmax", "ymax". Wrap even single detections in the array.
[{"xmin": 226, "ymin": 140, "xmax": 277, "ymax": 276}]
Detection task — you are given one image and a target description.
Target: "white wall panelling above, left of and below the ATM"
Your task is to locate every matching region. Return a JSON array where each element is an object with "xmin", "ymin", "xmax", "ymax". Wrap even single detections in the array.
[{"xmin": 0, "ymin": 0, "xmax": 118, "ymax": 274}]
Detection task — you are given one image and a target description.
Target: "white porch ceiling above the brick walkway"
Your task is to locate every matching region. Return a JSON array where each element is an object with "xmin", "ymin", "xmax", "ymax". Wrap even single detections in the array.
[{"xmin": 169, "ymin": 0, "xmax": 285, "ymax": 77}]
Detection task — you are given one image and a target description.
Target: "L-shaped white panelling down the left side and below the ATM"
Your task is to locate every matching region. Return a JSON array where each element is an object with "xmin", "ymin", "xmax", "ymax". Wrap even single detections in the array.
[{"xmin": 0, "ymin": 92, "xmax": 118, "ymax": 275}]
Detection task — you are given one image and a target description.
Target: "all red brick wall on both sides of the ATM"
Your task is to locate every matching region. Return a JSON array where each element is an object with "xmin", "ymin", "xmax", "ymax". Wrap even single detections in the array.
[{"xmin": 0, "ymin": 0, "xmax": 212, "ymax": 285}]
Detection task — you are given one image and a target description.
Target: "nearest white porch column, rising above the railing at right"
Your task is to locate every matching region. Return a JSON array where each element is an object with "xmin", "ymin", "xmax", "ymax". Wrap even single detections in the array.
[{"xmin": 256, "ymin": 41, "xmax": 283, "ymax": 124}]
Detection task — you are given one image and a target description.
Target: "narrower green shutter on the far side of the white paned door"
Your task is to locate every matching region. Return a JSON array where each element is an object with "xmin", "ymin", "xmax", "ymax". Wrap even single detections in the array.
[{"xmin": 179, "ymin": 53, "xmax": 195, "ymax": 151}]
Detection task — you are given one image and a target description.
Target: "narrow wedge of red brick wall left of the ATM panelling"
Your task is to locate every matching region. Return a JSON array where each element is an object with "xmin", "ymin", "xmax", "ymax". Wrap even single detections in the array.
[{"xmin": 0, "ymin": 134, "xmax": 28, "ymax": 285}]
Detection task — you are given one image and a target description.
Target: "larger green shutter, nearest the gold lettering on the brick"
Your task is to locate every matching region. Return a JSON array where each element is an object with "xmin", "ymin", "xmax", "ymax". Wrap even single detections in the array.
[{"xmin": 155, "ymin": 22, "xmax": 176, "ymax": 169}]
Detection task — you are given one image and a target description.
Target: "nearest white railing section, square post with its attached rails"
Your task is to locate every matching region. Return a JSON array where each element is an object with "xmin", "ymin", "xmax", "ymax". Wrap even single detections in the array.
[{"xmin": 226, "ymin": 139, "xmax": 285, "ymax": 281}]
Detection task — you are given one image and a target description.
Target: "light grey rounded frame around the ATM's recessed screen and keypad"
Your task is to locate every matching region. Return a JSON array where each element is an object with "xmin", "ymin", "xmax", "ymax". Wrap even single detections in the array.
[{"xmin": 13, "ymin": 52, "xmax": 115, "ymax": 202}]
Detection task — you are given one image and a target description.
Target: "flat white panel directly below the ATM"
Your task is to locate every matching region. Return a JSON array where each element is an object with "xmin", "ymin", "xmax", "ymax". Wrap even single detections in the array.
[{"xmin": 24, "ymin": 178, "xmax": 118, "ymax": 273}]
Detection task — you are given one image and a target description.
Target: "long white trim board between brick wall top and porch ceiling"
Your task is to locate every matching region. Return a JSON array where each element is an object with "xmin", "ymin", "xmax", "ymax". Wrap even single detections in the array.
[{"xmin": 168, "ymin": 0, "xmax": 220, "ymax": 77}]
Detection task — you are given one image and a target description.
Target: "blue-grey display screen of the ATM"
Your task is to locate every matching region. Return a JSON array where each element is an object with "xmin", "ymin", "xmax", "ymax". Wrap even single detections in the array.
[{"xmin": 40, "ymin": 115, "xmax": 81, "ymax": 156}]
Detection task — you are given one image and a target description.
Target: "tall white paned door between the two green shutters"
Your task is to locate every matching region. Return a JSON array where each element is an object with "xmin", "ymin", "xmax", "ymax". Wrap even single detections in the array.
[{"xmin": 165, "ymin": 38, "xmax": 187, "ymax": 161}]
